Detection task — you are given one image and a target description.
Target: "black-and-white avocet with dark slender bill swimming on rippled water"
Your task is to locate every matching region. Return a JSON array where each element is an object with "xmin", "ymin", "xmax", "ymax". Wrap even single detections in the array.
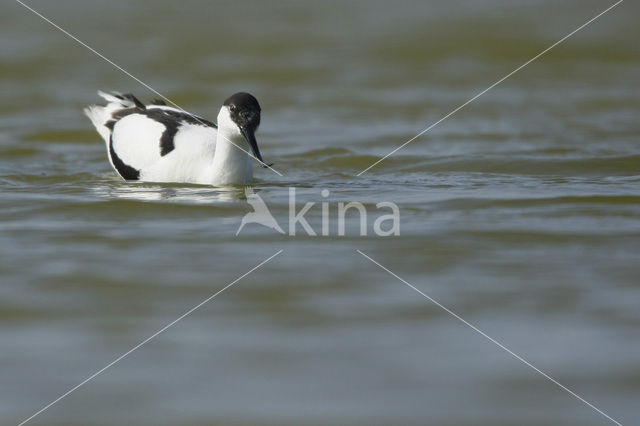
[{"xmin": 84, "ymin": 91, "xmax": 270, "ymax": 186}]
